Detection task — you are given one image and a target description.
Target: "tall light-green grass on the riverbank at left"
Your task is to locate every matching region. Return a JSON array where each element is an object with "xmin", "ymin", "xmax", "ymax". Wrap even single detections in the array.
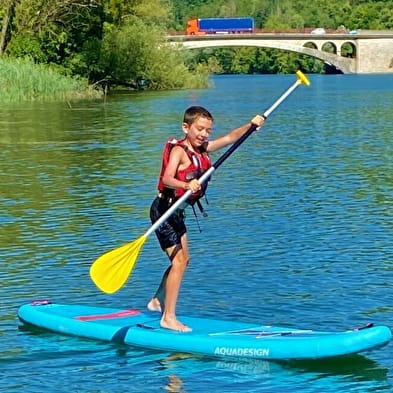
[{"xmin": 0, "ymin": 57, "xmax": 102, "ymax": 103}]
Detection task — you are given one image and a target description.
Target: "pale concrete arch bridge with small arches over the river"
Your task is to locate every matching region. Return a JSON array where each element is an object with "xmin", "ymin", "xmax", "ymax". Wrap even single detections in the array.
[{"xmin": 167, "ymin": 31, "xmax": 393, "ymax": 74}]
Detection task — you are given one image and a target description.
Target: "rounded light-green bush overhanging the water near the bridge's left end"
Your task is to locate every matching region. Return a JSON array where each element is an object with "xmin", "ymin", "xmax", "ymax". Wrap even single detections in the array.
[{"xmin": 100, "ymin": 17, "xmax": 208, "ymax": 89}]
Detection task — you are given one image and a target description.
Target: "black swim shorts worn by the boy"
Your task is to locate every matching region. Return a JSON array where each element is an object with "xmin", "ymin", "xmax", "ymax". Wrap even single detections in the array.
[{"xmin": 150, "ymin": 197, "xmax": 187, "ymax": 251}]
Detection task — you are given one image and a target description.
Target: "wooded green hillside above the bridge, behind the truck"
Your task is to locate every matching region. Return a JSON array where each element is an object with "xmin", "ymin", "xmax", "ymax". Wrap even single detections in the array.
[{"xmin": 168, "ymin": 0, "xmax": 393, "ymax": 30}]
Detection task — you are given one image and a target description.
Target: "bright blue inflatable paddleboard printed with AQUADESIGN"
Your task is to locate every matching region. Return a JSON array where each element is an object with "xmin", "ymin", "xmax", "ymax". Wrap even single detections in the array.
[{"xmin": 18, "ymin": 300, "xmax": 392, "ymax": 360}]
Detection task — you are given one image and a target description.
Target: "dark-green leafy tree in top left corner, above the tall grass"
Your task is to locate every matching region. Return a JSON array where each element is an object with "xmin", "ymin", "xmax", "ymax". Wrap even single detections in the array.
[{"xmin": 6, "ymin": 0, "xmax": 103, "ymax": 74}]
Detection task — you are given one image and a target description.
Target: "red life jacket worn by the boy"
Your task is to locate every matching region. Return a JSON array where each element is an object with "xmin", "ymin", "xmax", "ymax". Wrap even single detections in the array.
[{"xmin": 158, "ymin": 138, "xmax": 211, "ymax": 201}]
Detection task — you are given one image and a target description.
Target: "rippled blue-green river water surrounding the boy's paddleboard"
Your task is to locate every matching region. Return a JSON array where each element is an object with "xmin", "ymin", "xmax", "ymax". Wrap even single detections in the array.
[{"xmin": 0, "ymin": 75, "xmax": 393, "ymax": 393}]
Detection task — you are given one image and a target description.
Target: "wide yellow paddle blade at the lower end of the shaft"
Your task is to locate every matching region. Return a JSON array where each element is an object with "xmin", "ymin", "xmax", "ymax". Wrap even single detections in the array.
[{"xmin": 90, "ymin": 235, "xmax": 147, "ymax": 293}]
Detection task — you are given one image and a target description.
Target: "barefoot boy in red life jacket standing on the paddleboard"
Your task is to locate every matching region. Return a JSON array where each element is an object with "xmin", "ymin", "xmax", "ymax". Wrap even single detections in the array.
[{"xmin": 147, "ymin": 106, "xmax": 264, "ymax": 332}]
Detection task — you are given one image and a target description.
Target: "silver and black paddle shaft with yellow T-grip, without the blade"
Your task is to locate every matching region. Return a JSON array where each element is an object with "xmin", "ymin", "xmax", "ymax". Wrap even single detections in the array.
[{"xmin": 144, "ymin": 71, "xmax": 310, "ymax": 237}]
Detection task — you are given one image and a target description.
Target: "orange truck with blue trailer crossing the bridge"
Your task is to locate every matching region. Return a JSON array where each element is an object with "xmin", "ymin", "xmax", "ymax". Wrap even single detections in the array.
[{"xmin": 186, "ymin": 18, "xmax": 254, "ymax": 35}]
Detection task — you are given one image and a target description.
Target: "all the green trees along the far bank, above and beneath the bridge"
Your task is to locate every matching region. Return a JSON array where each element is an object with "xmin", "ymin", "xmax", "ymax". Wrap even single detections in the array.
[{"xmin": 0, "ymin": 0, "xmax": 393, "ymax": 89}]
